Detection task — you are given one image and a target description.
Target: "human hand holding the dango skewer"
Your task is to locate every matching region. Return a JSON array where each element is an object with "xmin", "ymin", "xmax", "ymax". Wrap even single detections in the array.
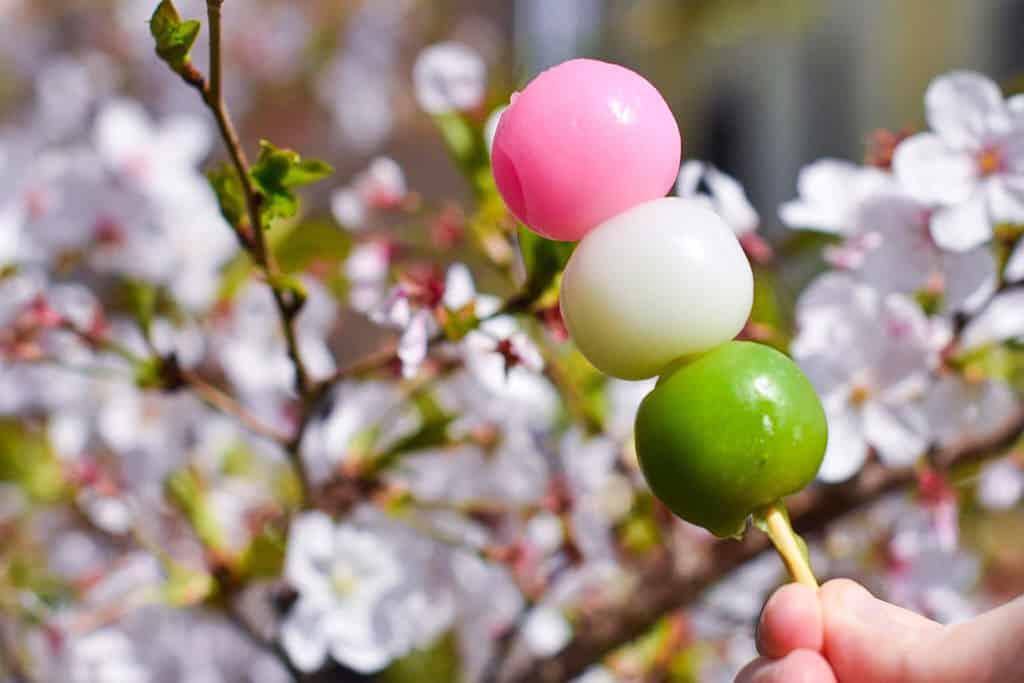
[{"xmin": 736, "ymin": 580, "xmax": 1024, "ymax": 683}]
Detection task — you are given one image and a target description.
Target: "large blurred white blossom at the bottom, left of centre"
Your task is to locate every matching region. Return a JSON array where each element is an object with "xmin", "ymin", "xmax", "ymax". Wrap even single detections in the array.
[{"xmin": 281, "ymin": 510, "xmax": 453, "ymax": 673}]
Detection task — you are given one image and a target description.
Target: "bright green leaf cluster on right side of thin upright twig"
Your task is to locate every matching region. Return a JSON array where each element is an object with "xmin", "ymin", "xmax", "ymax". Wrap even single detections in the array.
[{"xmin": 249, "ymin": 140, "xmax": 334, "ymax": 226}]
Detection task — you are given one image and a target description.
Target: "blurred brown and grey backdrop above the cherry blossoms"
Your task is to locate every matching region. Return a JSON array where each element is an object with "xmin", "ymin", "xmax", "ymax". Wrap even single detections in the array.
[{"xmin": 8, "ymin": 0, "xmax": 1024, "ymax": 239}]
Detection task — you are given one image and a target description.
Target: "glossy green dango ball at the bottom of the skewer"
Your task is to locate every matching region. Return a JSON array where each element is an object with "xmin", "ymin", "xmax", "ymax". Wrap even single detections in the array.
[{"xmin": 636, "ymin": 341, "xmax": 827, "ymax": 537}]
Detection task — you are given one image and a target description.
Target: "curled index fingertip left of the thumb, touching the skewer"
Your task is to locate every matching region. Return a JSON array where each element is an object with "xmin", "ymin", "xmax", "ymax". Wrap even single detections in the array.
[{"xmin": 758, "ymin": 584, "xmax": 824, "ymax": 659}]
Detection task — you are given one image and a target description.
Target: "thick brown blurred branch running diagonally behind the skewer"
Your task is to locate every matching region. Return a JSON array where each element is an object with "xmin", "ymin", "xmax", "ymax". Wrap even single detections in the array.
[{"xmin": 500, "ymin": 410, "xmax": 1024, "ymax": 683}]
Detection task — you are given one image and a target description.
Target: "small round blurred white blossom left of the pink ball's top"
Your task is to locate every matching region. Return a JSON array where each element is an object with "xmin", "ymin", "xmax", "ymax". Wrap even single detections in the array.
[{"xmin": 413, "ymin": 42, "xmax": 487, "ymax": 115}]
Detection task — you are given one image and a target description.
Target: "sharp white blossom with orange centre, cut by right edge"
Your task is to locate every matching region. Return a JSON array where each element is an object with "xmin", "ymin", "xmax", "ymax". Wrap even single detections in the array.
[{"xmin": 893, "ymin": 71, "xmax": 1024, "ymax": 252}]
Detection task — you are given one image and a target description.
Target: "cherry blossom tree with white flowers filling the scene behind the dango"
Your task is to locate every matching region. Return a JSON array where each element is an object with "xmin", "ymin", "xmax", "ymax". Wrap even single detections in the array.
[{"xmin": 0, "ymin": 0, "xmax": 1024, "ymax": 683}]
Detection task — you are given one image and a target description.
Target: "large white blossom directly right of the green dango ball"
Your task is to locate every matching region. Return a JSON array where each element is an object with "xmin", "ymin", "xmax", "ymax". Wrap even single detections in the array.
[{"xmin": 792, "ymin": 272, "xmax": 937, "ymax": 481}]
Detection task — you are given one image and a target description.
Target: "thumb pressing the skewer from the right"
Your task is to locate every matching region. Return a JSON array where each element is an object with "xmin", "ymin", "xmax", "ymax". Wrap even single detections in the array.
[{"xmin": 820, "ymin": 580, "xmax": 1024, "ymax": 683}]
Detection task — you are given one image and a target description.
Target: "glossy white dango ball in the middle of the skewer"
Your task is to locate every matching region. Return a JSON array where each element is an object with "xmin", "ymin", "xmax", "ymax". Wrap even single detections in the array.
[{"xmin": 561, "ymin": 197, "xmax": 754, "ymax": 380}]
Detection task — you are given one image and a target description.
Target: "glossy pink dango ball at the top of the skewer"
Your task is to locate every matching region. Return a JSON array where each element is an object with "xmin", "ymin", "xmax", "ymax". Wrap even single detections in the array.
[{"xmin": 492, "ymin": 59, "xmax": 682, "ymax": 241}]
